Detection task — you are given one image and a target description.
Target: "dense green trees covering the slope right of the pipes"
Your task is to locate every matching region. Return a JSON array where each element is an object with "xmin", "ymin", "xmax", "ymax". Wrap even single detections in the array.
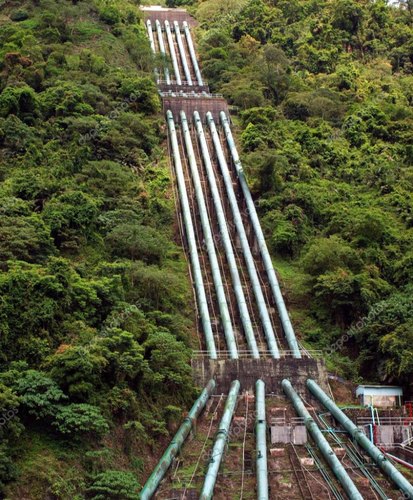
[{"xmin": 195, "ymin": 0, "xmax": 413, "ymax": 383}]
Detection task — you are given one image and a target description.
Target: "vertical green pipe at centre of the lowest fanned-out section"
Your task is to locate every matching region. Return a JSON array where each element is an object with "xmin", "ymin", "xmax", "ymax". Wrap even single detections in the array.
[{"xmin": 255, "ymin": 380, "xmax": 268, "ymax": 500}]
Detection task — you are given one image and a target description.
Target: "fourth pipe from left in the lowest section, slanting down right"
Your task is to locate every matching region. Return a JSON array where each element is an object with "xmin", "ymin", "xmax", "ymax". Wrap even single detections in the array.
[{"xmin": 282, "ymin": 379, "xmax": 363, "ymax": 500}]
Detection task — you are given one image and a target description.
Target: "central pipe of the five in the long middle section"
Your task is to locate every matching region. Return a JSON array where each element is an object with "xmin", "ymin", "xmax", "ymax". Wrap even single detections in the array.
[{"xmin": 194, "ymin": 111, "xmax": 260, "ymax": 359}]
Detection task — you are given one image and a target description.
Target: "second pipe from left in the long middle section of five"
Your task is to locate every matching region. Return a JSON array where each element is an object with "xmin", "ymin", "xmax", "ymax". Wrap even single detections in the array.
[{"xmin": 181, "ymin": 111, "xmax": 238, "ymax": 359}]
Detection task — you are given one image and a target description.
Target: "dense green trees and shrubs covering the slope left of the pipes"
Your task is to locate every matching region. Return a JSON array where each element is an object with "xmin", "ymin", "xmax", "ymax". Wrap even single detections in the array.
[{"xmin": 0, "ymin": 0, "xmax": 194, "ymax": 500}]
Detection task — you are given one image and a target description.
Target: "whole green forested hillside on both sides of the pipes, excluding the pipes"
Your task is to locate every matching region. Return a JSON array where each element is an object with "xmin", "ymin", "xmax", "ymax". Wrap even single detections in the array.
[{"xmin": 0, "ymin": 0, "xmax": 413, "ymax": 500}]
